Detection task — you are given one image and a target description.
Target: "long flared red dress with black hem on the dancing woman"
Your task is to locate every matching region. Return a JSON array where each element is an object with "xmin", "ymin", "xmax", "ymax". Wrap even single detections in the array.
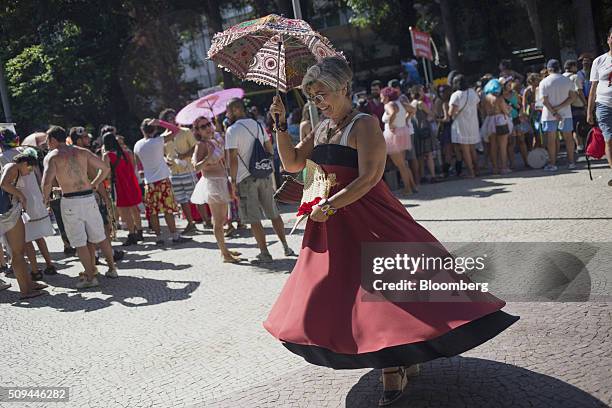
[{"xmin": 264, "ymin": 121, "xmax": 519, "ymax": 369}]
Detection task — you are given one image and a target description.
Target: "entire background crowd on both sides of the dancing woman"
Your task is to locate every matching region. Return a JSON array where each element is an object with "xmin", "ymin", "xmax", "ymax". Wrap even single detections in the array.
[{"xmin": 0, "ymin": 26, "xmax": 612, "ymax": 298}]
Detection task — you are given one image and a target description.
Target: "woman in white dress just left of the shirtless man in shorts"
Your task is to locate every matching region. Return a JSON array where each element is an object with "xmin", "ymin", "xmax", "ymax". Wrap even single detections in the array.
[{"xmin": 17, "ymin": 147, "xmax": 57, "ymax": 280}]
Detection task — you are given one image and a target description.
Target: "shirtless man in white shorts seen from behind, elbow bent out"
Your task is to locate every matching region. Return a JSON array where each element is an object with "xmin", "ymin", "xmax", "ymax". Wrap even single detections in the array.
[{"xmin": 42, "ymin": 126, "xmax": 117, "ymax": 289}]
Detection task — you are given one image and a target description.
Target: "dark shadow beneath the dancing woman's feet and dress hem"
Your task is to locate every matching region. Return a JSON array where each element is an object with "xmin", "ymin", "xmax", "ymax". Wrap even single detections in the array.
[{"xmin": 345, "ymin": 357, "xmax": 607, "ymax": 408}]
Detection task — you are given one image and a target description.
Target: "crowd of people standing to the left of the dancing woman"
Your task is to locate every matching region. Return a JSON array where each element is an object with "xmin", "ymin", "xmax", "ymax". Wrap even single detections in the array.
[{"xmin": 0, "ymin": 99, "xmax": 295, "ymax": 298}]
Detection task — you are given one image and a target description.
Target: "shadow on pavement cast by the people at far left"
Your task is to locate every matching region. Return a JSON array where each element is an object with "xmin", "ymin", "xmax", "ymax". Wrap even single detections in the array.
[{"xmin": 0, "ymin": 274, "xmax": 200, "ymax": 312}]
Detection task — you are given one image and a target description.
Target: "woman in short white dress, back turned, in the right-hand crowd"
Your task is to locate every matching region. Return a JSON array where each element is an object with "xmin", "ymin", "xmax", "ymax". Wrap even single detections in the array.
[{"xmin": 449, "ymin": 74, "xmax": 480, "ymax": 177}]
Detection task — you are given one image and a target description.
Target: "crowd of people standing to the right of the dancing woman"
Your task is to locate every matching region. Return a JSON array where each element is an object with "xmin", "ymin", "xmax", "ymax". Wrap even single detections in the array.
[{"xmin": 355, "ymin": 43, "xmax": 612, "ymax": 186}]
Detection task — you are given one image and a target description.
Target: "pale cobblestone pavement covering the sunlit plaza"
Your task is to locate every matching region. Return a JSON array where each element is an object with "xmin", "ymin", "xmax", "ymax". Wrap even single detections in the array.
[{"xmin": 0, "ymin": 163, "xmax": 612, "ymax": 408}]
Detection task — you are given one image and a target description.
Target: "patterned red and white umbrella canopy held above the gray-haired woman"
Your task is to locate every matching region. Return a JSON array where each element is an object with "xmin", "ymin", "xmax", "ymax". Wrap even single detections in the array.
[{"xmin": 208, "ymin": 14, "xmax": 344, "ymax": 92}]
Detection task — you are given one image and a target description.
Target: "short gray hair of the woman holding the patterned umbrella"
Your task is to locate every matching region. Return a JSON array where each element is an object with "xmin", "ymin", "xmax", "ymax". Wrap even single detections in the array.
[{"xmin": 302, "ymin": 57, "xmax": 353, "ymax": 96}]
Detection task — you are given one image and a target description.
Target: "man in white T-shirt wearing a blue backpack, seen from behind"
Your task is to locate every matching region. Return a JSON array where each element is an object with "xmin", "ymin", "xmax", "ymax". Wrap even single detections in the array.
[{"xmin": 225, "ymin": 98, "xmax": 294, "ymax": 263}]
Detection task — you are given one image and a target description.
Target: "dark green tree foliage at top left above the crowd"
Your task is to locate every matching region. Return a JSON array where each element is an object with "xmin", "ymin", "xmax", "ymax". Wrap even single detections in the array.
[{"xmin": 0, "ymin": 0, "xmax": 203, "ymax": 139}]
